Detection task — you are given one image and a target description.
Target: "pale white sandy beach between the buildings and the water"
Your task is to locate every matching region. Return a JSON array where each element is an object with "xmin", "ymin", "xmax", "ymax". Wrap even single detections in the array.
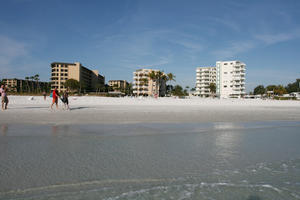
[{"xmin": 0, "ymin": 96, "xmax": 300, "ymax": 125}]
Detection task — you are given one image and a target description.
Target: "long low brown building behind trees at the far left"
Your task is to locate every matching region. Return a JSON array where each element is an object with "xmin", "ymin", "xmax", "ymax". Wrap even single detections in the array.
[{"xmin": 2, "ymin": 78, "xmax": 50, "ymax": 93}]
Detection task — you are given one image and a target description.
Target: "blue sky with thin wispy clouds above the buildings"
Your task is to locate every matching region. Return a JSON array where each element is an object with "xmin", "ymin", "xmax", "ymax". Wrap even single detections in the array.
[{"xmin": 0, "ymin": 0, "xmax": 300, "ymax": 92}]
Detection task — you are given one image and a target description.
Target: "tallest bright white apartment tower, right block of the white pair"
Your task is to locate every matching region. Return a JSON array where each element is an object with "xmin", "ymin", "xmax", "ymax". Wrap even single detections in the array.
[{"xmin": 216, "ymin": 61, "xmax": 246, "ymax": 98}]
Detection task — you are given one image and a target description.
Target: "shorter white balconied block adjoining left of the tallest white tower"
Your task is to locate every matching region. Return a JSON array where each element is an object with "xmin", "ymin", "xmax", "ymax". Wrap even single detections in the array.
[{"xmin": 195, "ymin": 67, "xmax": 216, "ymax": 97}]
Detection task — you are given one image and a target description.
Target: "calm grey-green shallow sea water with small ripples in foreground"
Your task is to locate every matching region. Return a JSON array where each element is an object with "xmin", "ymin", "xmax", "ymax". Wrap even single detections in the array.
[{"xmin": 0, "ymin": 121, "xmax": 300, "ymax": 200}]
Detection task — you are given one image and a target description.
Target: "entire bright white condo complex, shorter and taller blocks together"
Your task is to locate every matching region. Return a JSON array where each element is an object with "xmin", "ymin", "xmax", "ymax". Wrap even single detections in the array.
[{"xmin": 195, "ymin": 61, "xmax": 246, "ymax": 98}]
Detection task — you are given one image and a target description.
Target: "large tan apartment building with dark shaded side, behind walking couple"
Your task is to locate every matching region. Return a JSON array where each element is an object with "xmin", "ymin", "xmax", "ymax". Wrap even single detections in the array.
[{"xmin": 51, "ymin": 62, "xmax": 105, "ymax": 91}]
